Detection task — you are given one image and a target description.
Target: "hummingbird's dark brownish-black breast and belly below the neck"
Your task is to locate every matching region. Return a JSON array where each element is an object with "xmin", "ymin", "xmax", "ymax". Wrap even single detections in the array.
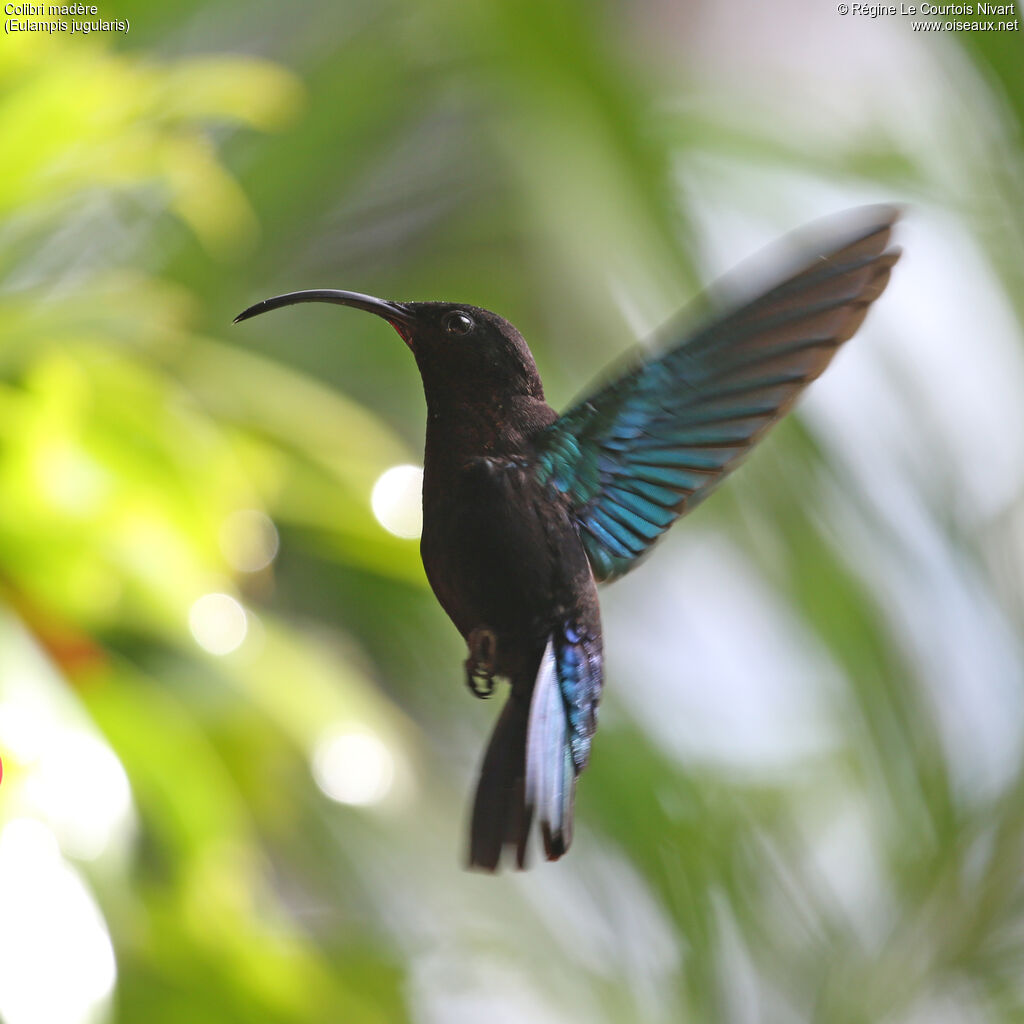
[{"xmin": 421, "ymin": 457, "xmax": 597, "ymax": 675}]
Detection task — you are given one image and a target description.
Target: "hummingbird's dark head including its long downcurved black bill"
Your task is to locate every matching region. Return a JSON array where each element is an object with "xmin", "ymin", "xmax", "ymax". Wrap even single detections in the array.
[{"xmin": 234, "ymin": 289, "xmax": 544, "ymax": 400}]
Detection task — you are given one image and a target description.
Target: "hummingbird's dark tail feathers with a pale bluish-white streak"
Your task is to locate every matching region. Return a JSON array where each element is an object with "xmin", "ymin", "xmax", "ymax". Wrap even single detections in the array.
[{"xmin": 469, "ymin": 638, "xmax": 583, "ymax": 871}]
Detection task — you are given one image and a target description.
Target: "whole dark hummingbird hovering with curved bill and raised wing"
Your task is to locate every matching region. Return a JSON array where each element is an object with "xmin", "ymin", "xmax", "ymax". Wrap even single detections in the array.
[{"xmin": 236, "ymin": 206, "xmax": 900, "ymax": 871}]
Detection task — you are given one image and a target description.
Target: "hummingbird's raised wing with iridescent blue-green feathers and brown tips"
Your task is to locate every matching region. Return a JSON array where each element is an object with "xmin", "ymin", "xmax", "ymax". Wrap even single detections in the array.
[{"xmin": 537, "ymin": 207, "xmax": 899, "ymax": 580}]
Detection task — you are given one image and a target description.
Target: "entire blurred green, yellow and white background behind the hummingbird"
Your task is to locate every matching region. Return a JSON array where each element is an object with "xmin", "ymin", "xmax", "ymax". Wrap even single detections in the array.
[{"xmin": 0, "ymin": 0, "xmax": 1024, "ymax": 1024}]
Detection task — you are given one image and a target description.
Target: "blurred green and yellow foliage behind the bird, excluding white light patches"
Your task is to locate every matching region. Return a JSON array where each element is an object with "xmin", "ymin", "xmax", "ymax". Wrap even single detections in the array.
[{"xmin": 0, "ymin": 0, "xmax": 1024, "ymax": 1024}]
